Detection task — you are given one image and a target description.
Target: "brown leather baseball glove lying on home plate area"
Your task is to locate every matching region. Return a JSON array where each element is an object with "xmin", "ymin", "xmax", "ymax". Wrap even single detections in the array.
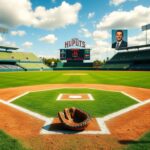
[{"xmin": 58, "ymin": 107, "xmax": 91, "ymax": 131}]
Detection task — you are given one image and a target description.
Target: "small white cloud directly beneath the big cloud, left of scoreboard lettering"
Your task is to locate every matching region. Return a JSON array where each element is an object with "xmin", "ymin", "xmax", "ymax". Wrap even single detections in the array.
[{"xmin": 39, "ymin": 34, "xmax": 57, "ymax": 44}]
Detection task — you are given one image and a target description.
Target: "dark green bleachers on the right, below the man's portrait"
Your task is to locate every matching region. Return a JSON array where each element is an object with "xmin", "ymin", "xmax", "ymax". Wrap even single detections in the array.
[{"xmin": 101, "ymin": 49, "xmax": 150, "ymax": 70}]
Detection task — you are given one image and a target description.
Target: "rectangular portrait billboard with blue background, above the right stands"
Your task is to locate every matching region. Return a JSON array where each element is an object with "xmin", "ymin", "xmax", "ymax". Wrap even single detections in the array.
[{"xmin": 112, "ymin": 29, "xmax": 128, "ymax": 50}]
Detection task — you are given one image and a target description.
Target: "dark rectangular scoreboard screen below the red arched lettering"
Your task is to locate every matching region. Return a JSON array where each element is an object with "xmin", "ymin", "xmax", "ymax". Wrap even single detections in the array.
[{"xmin": 60, "ymin": 48, "xmax": 90, "ymax": 61}]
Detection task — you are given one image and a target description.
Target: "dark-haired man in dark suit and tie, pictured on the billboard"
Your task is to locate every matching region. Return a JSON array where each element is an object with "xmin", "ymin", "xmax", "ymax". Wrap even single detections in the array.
[{"xmin": 112, "ymin": 30, "xmax": 127, "ymax": 49}]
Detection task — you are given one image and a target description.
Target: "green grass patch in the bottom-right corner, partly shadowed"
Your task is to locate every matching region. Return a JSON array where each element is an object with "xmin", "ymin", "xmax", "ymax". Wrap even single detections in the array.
[{"xmin": 126, "ymin": 132, "xmax": 150, "ymax": 150}]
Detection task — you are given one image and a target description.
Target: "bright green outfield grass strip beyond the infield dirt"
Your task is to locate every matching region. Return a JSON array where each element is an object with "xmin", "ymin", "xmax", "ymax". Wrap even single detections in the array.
[{"xmin": 0, "ymin": 71, "xmax": 150, "ymax": 88}]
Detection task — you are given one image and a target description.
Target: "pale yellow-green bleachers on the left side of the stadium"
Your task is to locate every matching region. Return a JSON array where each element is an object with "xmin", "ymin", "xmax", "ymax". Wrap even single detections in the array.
[{"xmin": 0, "ymin": 46, "xmax": 52, "ymax": 71}]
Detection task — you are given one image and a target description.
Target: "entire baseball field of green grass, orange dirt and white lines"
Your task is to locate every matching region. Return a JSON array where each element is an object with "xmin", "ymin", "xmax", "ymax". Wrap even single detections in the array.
[{"xmin": 0, "ymin": 71, "xmax": 150, "ymax": 150}]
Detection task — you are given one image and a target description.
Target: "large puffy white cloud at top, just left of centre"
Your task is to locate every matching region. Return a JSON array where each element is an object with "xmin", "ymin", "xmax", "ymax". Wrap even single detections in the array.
[{"xmin": 34, "ymin": 2, "xmax": 81, "ymax": 29}]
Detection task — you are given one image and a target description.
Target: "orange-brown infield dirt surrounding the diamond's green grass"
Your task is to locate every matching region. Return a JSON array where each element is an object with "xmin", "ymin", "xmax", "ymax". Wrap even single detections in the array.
[{"xmin": 0, "ymin": 84, "xmax": 150, "ymax": 150}]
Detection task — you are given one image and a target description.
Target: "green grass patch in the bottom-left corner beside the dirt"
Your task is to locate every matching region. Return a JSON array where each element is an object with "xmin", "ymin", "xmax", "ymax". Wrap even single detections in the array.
[{"xmin": 0, "ymin": 130, "xmax": 27, "ymax": 150}]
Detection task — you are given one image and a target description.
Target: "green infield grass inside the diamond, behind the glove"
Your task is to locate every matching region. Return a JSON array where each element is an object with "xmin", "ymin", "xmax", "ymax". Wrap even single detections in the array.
[{"xmin": 13, "ymin": 89, "xmax": 137, "ymax": 117}]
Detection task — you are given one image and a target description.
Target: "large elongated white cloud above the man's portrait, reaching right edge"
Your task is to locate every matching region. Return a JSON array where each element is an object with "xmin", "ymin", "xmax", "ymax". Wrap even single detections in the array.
[{"xmin": 97, "ymin": 5, "xmax": 150, "ymax": 30}]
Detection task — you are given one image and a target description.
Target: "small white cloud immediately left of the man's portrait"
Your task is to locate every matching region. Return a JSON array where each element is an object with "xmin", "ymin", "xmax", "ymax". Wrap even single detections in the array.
[{"xmin": 93, "ymin": 30, "xmax": 110, "ymax": 40}]
